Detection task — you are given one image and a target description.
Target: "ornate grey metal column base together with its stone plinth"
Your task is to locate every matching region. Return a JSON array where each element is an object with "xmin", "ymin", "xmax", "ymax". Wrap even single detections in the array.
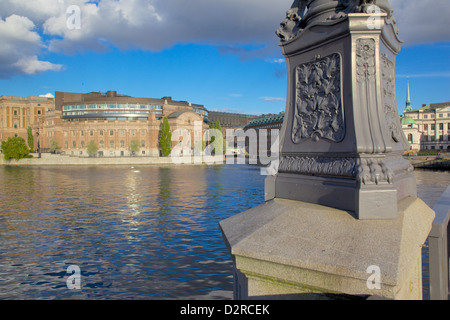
[{"xmin": 220, "ymin": 0, "xmax": 434, "ymax": 299}]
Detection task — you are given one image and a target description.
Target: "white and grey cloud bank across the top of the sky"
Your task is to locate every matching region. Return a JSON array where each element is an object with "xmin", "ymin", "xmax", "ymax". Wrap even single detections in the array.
[{"xmin": 0, "ymin": 0, "xmax": 450, "ymax": 77}]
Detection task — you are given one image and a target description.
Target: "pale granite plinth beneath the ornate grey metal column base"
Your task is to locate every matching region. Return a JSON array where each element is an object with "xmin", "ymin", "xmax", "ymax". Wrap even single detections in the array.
[{"xmin": 220, "ymin": 198, "xmax": 434, "ymax": 300}]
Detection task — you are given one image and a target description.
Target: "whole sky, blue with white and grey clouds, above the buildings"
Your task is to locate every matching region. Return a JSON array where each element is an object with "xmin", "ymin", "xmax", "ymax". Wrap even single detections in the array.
[{"xmin": 0, "ymin": 0, "xmax": 450, "ymax": 114}]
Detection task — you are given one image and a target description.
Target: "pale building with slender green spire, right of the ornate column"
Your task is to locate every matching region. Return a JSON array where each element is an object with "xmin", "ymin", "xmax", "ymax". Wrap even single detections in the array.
[{"xmin": 400, "ymin": 83, "xmax": 450, "ymax": 152}]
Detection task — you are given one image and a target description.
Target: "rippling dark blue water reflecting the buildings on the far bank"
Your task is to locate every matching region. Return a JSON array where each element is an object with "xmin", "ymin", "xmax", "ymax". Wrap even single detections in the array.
[{"xmin": 0, "ymin": 165, "xmax": 450, "ymax": 299}]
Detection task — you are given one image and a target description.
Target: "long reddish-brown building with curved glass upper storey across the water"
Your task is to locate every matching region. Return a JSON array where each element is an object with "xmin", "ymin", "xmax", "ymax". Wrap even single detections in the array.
[{"xmin": 0, "ymin": 91, "xmax": 208, "ymax": 157}]
